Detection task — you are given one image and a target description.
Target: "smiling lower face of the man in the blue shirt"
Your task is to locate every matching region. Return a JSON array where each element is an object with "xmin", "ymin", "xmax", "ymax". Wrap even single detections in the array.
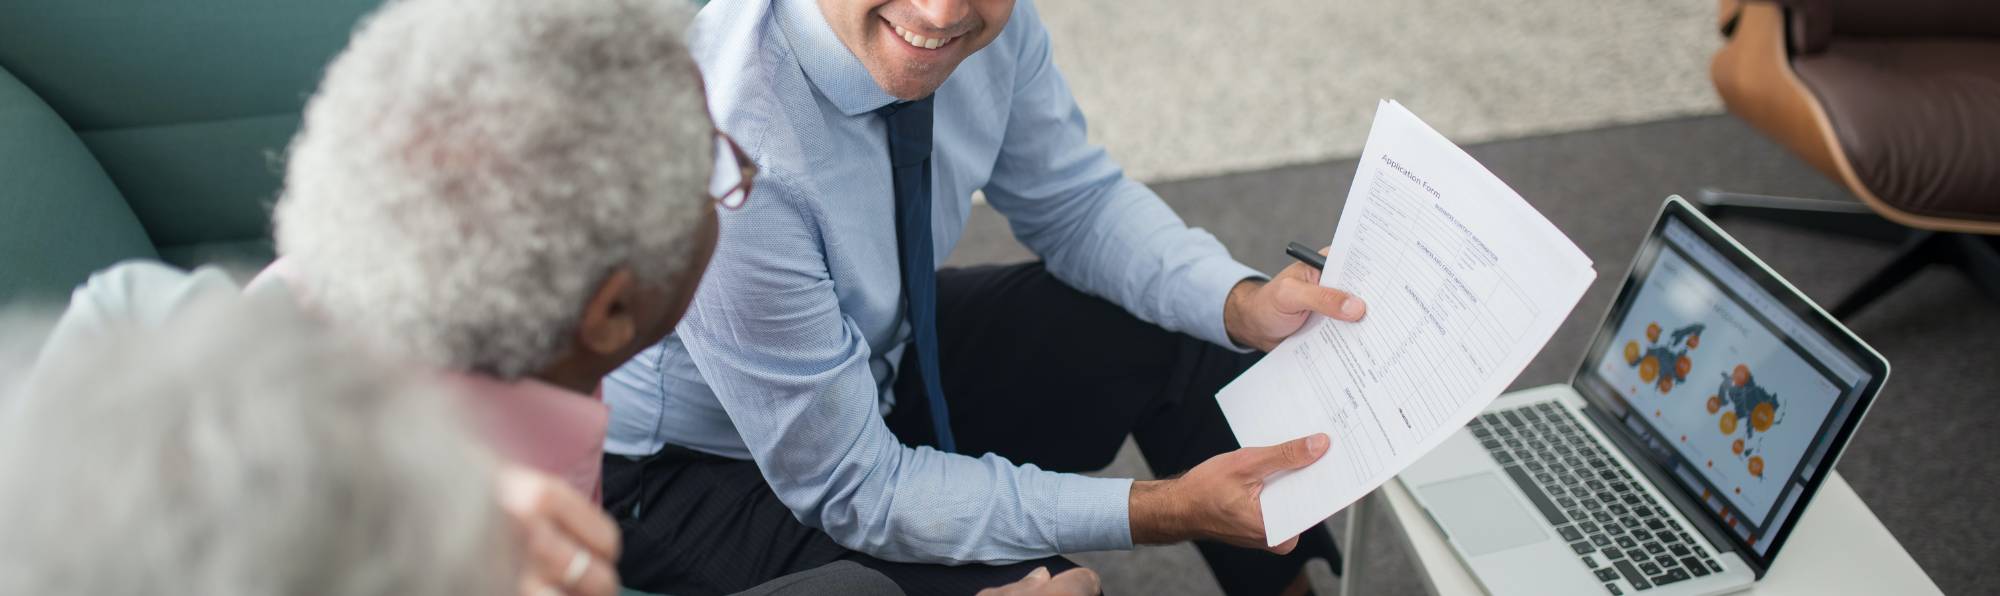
[{"xmin": 820, "ymin": 0, "xmax": 1014, "ymax": 100}]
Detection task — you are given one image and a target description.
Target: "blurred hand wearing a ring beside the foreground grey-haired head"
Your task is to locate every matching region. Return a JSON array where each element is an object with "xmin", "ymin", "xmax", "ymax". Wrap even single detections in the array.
[{"xmin": 500, "ymin": 466, "xmax": 618, "ymax": 596}]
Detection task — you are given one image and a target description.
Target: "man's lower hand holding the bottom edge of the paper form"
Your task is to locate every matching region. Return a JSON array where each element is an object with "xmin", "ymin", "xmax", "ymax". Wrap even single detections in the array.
[{"xmin": 1132, "ymin": 434, "xmax": 1328, "ymax": 554}]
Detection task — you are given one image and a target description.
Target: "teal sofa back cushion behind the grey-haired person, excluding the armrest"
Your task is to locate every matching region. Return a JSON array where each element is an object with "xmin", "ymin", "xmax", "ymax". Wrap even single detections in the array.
[{"xmin": 0, "ymin": 0, "xmax": 380, "ymax": 266}]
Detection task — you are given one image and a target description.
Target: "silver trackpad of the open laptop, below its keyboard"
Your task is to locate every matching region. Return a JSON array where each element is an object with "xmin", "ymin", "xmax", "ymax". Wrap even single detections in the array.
[{"xmin": 1418, "ymin": 472, "xmax": 1548, "ymax": 556}]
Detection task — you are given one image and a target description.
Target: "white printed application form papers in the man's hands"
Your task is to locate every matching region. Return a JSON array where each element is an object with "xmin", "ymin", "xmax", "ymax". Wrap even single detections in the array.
[{"xmin": 1216, "ymin": 102, "xmax": 1596, "ymax": 546}]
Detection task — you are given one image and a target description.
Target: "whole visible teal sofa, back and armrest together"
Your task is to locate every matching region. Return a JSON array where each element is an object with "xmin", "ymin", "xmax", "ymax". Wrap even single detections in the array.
[{"xmin": 0, "ymin": 0, "xmax": 380, "ymax": 304}]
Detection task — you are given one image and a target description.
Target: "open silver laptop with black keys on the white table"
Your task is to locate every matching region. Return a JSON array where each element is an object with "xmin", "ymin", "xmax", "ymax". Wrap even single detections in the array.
[{"xmin": 1398, "ymin": 196, "xmax": 1888, "ymax": 596}]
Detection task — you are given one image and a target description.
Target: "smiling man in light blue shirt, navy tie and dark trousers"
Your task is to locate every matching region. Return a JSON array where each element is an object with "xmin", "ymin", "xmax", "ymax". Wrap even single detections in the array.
[{"xmin": 604, "ymin": 0, "xmax": 1364, "ymax": 594}]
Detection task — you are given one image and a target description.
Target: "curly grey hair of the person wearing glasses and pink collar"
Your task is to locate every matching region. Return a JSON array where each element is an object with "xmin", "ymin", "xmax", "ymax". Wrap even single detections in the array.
[{"xmin": 274, "ymin": 0, "xmax": 714, "ymax": 380}]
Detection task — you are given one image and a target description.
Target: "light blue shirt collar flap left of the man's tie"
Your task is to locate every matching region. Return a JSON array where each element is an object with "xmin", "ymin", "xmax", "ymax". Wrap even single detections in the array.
[{"xmin": 776, "ymin": 0, "xmax": 898, "ymax": 116}]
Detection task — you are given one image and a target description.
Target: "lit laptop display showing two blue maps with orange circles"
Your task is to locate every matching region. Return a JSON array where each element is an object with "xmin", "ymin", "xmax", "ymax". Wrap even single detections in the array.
[{"xmin": 1596, "ymin": 244, "xmax": 1842, "ymax": 526}]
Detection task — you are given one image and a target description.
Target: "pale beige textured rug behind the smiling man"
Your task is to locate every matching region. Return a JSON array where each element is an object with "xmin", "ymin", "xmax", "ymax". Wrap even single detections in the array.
[{"xmin": 1036, "ymin": 0, "xmax": 1722, "ymax": 180}]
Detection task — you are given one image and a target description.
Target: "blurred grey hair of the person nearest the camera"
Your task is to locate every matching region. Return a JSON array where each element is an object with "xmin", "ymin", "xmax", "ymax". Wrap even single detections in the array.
[{"xmin": 0, "ymin": 296, "xmax": 520, "ymax": 596}]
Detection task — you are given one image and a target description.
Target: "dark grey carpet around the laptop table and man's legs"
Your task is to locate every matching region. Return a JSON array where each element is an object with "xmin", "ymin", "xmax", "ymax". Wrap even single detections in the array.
[{"xmin": 950, "ymin": 116, "xmax": 2000, "ymax": 594}]
